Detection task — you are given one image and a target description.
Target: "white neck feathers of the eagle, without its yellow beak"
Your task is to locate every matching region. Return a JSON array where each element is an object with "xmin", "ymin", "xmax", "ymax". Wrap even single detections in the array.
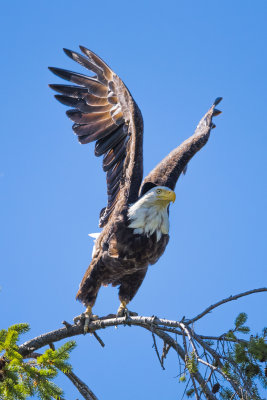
[{"xmin": 128, "ymin": 193, "xmax": 169, "ymax": 241}]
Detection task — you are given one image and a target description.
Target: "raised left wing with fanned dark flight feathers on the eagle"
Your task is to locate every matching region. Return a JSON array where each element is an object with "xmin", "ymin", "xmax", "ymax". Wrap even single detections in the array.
[{"xmin": 49, "ymin": 46, "xmax": 143, "ymax": 227}]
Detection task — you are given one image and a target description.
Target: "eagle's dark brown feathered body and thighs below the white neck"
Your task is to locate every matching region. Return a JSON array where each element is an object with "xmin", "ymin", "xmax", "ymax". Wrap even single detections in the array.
[{"xmin": 77, "ymin": 209, "xmax": 169, "ymax": 305}]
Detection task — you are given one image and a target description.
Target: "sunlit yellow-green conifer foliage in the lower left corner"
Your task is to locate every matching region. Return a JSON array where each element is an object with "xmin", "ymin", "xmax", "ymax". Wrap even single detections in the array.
[{"xmin": 0, "ymin": 323, "xmax": 75, "ymax": 400}]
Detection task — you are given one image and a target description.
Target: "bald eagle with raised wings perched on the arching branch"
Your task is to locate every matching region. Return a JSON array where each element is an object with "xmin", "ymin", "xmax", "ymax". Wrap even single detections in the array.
[{"xmin": 50, "ymin": 46, "xmax": 221, "ymax": 330}]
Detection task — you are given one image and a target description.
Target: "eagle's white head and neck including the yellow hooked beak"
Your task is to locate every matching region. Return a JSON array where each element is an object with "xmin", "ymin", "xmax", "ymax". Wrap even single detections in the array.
[{"xmin": 128, "ymin": 186, "xmax": 176, "ymax": 241}]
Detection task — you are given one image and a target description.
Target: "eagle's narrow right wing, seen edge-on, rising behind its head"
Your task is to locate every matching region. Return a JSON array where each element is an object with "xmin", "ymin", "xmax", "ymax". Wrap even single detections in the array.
[{"xmin": 139, "ymin": 97, "xmax": 222, "ymax": 196}]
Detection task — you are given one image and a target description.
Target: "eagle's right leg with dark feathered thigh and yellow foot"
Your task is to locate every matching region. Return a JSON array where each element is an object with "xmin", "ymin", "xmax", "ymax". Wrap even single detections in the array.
[{"xmin": 117, "ymin": 267, "xmax": 150, "ymax": 317}]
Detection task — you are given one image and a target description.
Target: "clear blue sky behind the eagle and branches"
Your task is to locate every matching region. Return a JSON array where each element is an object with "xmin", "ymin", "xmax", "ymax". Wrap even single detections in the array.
[{"xmin": 0, "ymin": 0, "xmax": 267, "ymax": 400}]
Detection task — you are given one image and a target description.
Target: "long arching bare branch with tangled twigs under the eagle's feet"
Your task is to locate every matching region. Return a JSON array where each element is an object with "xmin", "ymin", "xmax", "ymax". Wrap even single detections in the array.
[{"xmin": 15, "ymin": 288, "xmax": 267, "ymax": 400}]
